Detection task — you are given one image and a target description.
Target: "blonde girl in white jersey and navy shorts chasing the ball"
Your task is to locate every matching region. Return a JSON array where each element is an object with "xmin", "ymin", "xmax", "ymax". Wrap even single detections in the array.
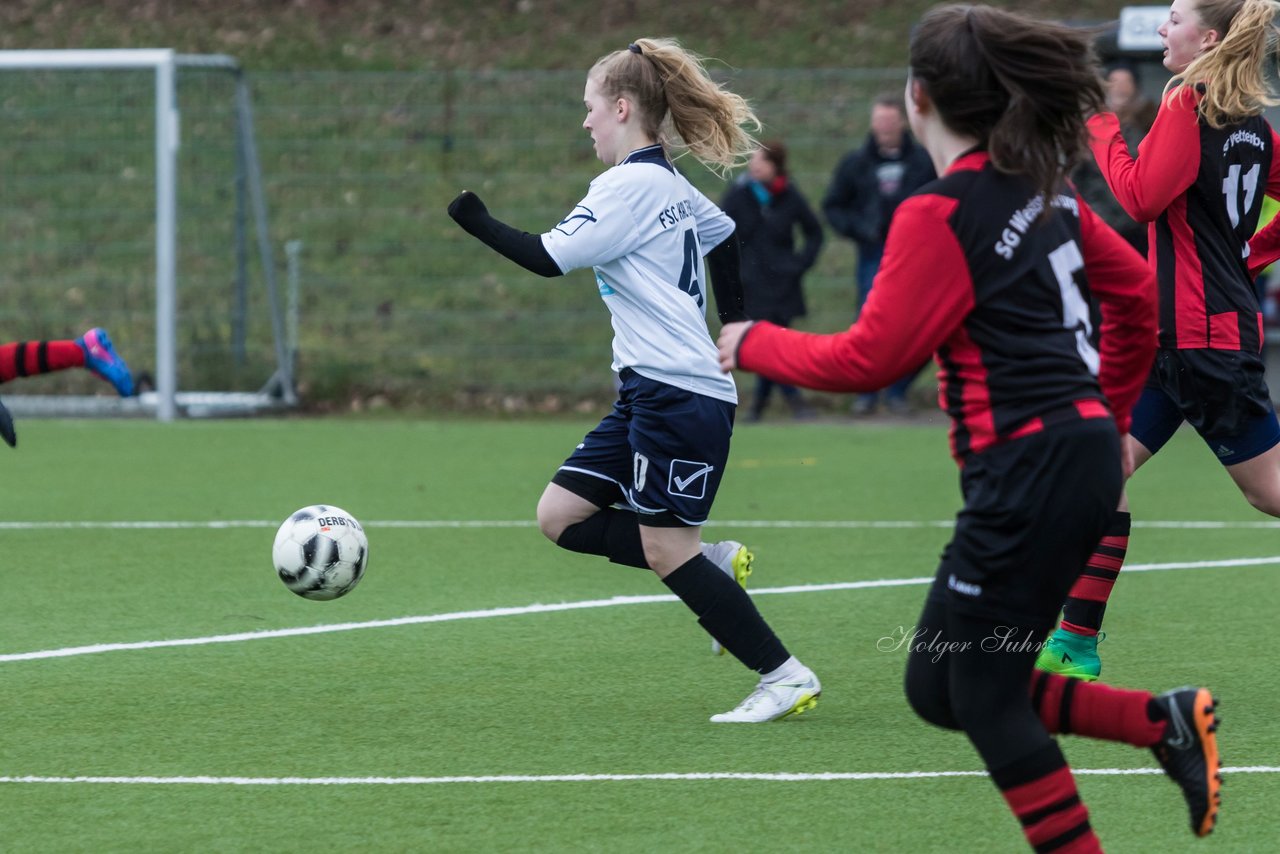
[{"xmin": 449, "ymin": 38, "xmax": 822, "ymax": 723}]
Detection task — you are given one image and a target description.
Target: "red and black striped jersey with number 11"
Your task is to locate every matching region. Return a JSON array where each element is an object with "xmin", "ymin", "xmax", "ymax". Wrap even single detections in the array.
[{"xmin": 1089, "ymin": 86, "xmax": 1280, "ymax": 352}]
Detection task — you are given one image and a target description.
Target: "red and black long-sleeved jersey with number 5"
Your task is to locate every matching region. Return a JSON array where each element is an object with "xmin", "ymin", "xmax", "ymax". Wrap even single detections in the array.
[{"xmin": 737, "ymin": 151, "xmax": 1156, "ymax": 463}]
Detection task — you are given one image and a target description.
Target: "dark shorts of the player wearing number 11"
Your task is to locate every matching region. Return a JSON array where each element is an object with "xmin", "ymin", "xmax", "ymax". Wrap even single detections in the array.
[{"xmin": 1129, "ymin": 347, "xmax": 1280, "ymax": 466}]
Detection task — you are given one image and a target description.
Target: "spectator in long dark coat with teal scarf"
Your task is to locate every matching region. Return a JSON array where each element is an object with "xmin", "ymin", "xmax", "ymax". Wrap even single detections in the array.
[{"xmin": 721, "ymin": 141, "xmax": 823, "ymax": 421}]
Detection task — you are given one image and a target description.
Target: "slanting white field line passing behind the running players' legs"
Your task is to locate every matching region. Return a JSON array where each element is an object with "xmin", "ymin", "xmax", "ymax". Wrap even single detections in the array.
[{"xmin": 0, "ymin": 556, "xmax": 1280, "ymax": 663}]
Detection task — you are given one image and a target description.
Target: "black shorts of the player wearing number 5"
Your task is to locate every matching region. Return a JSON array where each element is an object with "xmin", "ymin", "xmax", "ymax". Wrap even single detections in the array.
[{"xmin": 929, "ymin": 419, "xmax": 1123, "ymax": 631}]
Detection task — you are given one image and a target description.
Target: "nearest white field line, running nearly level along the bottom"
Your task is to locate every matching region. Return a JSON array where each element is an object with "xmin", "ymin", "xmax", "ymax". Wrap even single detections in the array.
[{"xmin": 0, "ymin": 766, "xmax": 1280, "ymax": 786}]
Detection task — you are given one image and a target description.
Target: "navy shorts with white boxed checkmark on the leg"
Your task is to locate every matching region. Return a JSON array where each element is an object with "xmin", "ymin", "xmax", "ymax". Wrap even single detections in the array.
[{"xmin": 552, "ymin": 370, "xmax": 737, "ymax": 528}]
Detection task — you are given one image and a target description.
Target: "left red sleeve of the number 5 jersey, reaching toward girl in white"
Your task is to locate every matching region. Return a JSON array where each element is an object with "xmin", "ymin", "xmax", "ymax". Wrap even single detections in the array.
[{"xmin": 737, "ymin": 195, "xmax": 974, "ymax": 392}]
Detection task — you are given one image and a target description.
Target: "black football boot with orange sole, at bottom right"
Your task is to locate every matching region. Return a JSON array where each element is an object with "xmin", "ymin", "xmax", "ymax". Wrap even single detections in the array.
[{"xmin": 1151, "ymin": 688, "xmax": 1222, "ymax": 836}]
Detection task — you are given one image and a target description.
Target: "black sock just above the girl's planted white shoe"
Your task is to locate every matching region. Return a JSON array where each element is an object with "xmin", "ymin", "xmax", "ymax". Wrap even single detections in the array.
[{"xmin": 663, "ymin": 554, "xmax": 791, "ymax": 673}]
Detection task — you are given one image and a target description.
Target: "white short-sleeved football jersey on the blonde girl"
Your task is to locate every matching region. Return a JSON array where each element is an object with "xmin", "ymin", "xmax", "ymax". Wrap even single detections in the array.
[{"xmin": 543, "ymin": 145, "xmax": 737, "ymax": 403}]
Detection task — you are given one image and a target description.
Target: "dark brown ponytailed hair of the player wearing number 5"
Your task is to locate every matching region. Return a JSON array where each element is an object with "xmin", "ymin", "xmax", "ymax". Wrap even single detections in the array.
[{"xmin": 910, "ymin": 5, "xmax": 1105, "ymax": 201}]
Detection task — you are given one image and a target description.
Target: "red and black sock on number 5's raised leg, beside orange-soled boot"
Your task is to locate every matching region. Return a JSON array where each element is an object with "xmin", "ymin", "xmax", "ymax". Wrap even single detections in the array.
[{"xmin": 1032, "ymin": 670, "xmax": 1166, "ymax": 748}]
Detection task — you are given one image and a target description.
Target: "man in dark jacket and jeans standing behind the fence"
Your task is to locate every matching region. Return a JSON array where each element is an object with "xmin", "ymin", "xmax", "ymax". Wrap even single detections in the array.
[{"xmin": 822, "ymin": 95, "xmax": 937, "ymax": 414}]
